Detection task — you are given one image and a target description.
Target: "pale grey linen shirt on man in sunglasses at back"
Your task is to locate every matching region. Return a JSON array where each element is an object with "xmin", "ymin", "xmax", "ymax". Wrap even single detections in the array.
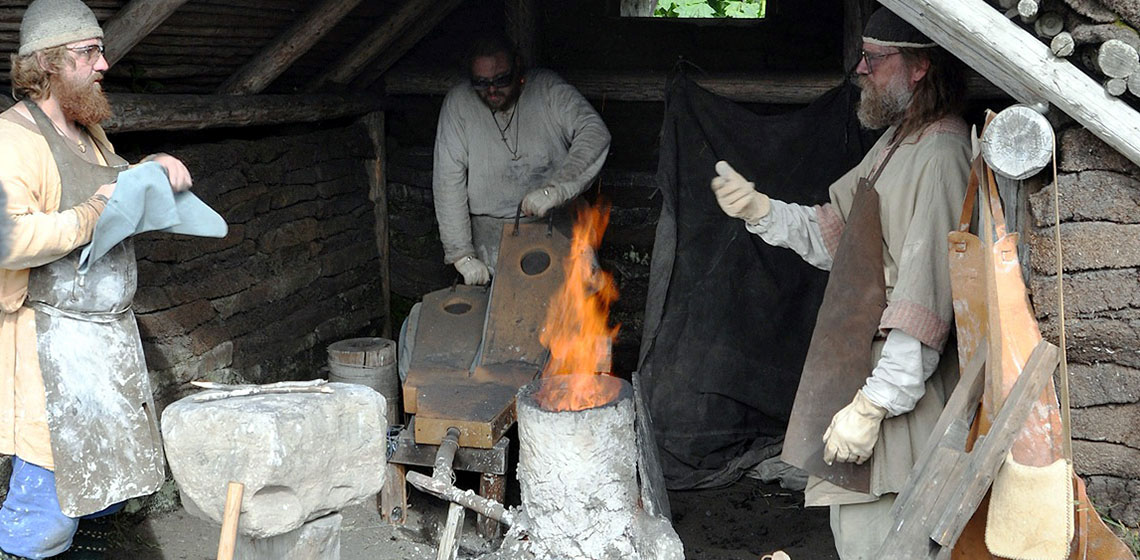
[{"xmin": 432, "ymin": 68, "xmax": 610, "ymax": 266}]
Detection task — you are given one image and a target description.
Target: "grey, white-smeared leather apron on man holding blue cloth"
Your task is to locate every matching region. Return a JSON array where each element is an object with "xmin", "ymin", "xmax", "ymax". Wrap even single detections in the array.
[{"xmin": 24, "ymin": 103, "xmax": 165, "ymax": 517}]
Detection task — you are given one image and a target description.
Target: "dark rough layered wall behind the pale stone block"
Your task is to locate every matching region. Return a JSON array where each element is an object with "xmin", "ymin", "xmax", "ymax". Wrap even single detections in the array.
[{"xmin": 115, "ymin": 125, "xmax": 388, "ymax": 407}]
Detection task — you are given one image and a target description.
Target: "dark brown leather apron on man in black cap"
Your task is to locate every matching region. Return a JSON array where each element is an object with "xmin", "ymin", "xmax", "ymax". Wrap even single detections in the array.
[{"xmin": 781, "ymin": 144, "xmax": 899, "ymax": 494}]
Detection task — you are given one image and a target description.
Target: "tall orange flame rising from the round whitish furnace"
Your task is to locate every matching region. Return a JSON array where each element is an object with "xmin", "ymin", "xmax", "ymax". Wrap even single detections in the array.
[{"xmin": 536, "ymin": 203, "xmax": 620, "ymax": 411}]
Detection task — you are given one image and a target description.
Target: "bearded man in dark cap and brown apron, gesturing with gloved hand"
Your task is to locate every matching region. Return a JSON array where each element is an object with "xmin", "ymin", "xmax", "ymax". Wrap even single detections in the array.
[{"xmin": 711, "ymin": 9, "xmax": 970, "ymax": 560}]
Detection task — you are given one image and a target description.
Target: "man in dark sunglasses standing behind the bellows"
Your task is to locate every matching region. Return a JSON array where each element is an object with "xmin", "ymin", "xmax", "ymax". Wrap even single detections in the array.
[{"xmin": 432, "ymin": 35, "xmax": 610, "ymax": 284}]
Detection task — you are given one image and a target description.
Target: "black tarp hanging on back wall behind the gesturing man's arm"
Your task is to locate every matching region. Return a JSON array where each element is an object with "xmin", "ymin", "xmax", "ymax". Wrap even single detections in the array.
[{"xmin": 638, "ymin": 75, "xmax": 876, "ymax": 489}]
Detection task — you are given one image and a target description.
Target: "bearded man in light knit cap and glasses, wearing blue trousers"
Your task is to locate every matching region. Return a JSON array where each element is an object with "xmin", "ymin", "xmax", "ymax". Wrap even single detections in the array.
[{"xmin": 0, "ymin": 0, "xmax": 190, "ymax": 559}]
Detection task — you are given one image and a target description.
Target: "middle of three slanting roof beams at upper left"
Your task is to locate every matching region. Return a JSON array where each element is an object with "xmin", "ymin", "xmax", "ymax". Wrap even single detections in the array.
[{"xmin": 218, "ymin": 0, "xmax": 360, "ymax": 95}]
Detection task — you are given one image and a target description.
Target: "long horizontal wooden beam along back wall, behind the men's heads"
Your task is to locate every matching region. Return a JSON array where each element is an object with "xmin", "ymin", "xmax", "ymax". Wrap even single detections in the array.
[{"xmin": 385, "ymin": 67, "xmax": 1002, "ymax": 104}]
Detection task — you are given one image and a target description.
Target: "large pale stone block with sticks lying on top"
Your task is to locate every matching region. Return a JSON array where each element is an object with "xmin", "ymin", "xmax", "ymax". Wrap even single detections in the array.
[{"xmin": 162, "ymin": 383, "xmax": 388, "ymax": 538}]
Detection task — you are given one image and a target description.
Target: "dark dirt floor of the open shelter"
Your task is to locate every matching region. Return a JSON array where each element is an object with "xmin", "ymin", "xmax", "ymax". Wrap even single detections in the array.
[{"xmin": 109, "ymin": 478, "xmax": 838, "ymax": 560}]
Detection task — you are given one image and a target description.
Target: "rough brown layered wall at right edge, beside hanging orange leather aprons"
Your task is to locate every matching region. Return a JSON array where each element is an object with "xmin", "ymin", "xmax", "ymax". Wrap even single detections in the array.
[{"xmin": 1025, "ymin": 127, "xmax": 1140, "ymax": 527}]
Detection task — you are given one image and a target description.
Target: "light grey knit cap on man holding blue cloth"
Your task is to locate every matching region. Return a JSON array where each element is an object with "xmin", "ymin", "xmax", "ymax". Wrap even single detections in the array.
[{"xmin": 19, "ymin": 0, "xmax": 103, "ymax": 56}]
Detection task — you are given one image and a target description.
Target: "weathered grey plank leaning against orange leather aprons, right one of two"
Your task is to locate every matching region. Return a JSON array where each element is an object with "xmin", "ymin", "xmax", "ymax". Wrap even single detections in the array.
[{"xmin": 930, "ymin": 340, "xmax": 1060, "ymax": 549}]
